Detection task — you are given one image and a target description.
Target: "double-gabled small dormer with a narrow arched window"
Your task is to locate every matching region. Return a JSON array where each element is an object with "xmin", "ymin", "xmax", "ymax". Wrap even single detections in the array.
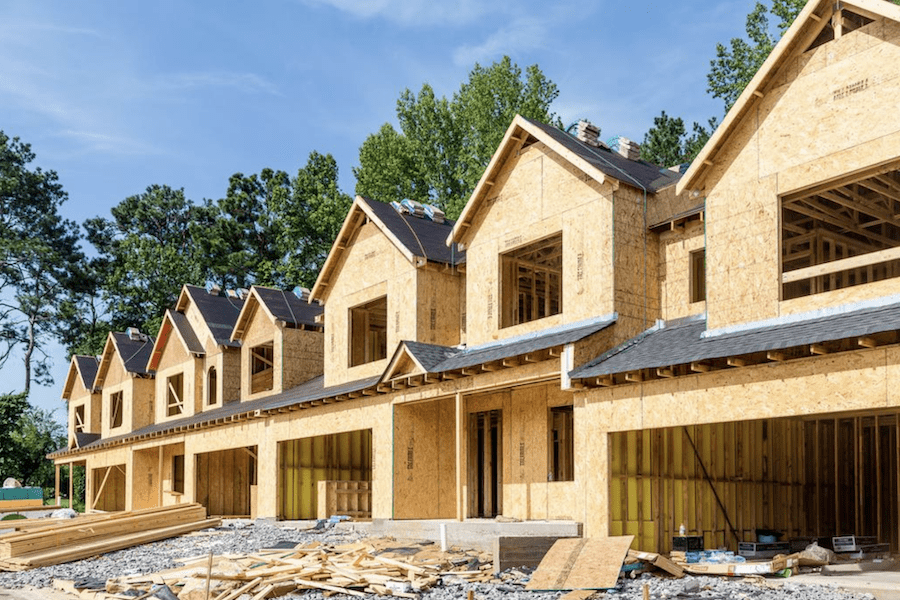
[{"xmin": 147, "ymin": 285, "xmax": 244, "ymax": 423}]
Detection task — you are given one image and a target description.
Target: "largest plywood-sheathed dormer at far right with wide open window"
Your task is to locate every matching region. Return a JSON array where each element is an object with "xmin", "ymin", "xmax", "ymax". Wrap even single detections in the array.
[{"xmin": 678, "ymin": 0, "xmax": 900, "ymax": 331}]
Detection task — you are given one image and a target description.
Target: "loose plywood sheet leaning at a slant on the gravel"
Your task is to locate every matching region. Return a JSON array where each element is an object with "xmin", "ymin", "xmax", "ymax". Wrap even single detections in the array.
[{"xmin": 525, "ymin": 535, "xmax": 634, "ymax": 590}]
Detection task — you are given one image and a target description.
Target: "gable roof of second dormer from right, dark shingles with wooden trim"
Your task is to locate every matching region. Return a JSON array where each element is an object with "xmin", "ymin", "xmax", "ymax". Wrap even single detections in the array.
[{"xmin": 447, "ymin": 115, "xmax": 681, "ymax": 244}]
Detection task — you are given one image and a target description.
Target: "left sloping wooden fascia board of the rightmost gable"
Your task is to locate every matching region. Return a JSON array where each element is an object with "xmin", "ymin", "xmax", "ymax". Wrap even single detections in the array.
[{"xmin": 675, "ymin": 0, "xmax": 832, "ymax": 195}]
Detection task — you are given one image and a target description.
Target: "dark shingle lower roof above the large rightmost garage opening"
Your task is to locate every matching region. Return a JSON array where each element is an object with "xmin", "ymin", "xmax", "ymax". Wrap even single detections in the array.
[{"xmin": 570, "ymin": 304, "xmax": 900, "ymax": 379}]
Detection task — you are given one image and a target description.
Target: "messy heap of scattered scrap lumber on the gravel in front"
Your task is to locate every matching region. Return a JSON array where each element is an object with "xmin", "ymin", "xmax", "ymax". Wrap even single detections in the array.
[{"xmin": 67, "ymin": 539, "xmax": 492, "ymax": 600}]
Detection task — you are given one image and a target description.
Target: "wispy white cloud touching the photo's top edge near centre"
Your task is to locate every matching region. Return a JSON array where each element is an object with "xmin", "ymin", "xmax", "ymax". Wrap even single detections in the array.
[{"xmin": 304, "ymin": 0, "xmax": 497, "ymax": 25}]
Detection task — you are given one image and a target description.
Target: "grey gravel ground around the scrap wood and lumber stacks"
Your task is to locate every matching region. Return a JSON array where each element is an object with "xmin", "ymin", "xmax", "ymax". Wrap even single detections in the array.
[{"xmin": 0, "ymin": 520, "xmax": 900, "ymax": 600}]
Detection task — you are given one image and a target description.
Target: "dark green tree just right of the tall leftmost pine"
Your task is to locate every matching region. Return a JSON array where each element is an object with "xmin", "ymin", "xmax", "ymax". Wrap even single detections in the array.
[{"xmin": 85, "ymin": 185, "xmax": 215, "ymax": 334}]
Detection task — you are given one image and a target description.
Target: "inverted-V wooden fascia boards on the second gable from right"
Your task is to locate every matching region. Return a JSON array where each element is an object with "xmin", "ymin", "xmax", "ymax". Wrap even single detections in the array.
[{"xmin": 447, "ymin": 115, "xmax": 606, "ymax": 246}]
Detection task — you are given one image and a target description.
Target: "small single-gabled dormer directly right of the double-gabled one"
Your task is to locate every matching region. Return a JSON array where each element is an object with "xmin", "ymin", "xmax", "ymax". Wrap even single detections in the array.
[{"xmin": 231, "ymin": 286, "xmax": 324, "ymax": 400}]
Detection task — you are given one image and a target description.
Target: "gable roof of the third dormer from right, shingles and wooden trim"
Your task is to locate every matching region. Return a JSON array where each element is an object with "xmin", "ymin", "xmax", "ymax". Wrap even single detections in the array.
[{"xmin": 310, "ymin": 196, "xmax": 466, "ymax": 300}]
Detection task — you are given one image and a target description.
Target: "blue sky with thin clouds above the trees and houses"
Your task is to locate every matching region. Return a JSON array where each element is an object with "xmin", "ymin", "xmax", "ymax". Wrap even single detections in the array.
[{"xmin": 0, "ymin": 0, "xmax": 753, "ymax": 422}]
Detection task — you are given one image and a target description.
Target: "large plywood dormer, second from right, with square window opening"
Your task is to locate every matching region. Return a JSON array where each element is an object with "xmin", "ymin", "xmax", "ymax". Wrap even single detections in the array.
[{"xmin": 447, "ymin": 116, "xmax": 680, "ymax": 345}]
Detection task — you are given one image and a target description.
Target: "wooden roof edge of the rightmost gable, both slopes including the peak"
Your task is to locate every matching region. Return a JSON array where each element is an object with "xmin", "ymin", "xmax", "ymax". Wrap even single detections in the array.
[{"xmin": 676, "ymin": 0, "xmax": 900, "ymax": 194}]
